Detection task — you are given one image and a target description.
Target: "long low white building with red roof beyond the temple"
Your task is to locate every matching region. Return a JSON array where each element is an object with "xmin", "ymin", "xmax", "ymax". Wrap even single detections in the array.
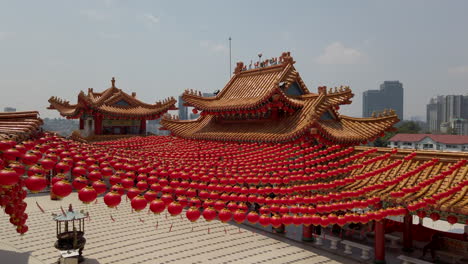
[{"xmin": 388, "ymin": 134, "xmax": 468, "ymax": 152}]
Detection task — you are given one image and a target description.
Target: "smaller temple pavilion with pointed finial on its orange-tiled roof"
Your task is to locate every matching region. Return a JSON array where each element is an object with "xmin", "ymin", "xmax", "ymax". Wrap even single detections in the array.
[{"xmin": 48, "ymin": 78, "xmax": 176, "ymax": 141}]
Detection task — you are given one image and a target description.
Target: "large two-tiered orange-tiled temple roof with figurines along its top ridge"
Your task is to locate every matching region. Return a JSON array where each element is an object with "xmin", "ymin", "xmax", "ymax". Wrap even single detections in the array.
[{"xmin": 161, "ymin": 52, "xmax": 399, "ymax": 145}]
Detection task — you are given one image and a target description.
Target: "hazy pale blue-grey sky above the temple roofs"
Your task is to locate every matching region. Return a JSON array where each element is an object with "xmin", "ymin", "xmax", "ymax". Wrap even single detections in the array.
[{"xmin": 0, "ymin": 0, "xmax": 468, "ymax": 118}]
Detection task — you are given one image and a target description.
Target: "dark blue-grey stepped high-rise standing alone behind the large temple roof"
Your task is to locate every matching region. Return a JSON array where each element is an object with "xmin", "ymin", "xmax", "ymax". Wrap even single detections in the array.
[{"xmin": 362, "ymin": 81, "xmax": 403, "ymax": 120}]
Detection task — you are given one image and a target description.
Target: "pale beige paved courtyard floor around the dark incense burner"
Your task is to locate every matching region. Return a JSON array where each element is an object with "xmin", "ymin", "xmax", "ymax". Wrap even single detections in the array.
[{"xmin": 0, "ymin": 193, "xmax": 355, "ymax": 264}]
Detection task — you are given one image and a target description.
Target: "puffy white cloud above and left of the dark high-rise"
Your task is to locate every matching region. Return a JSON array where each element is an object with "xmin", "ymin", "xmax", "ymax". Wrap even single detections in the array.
[{"xmin": 315, "ymin": 42, "xmax": 366, "ymax": 64}]
